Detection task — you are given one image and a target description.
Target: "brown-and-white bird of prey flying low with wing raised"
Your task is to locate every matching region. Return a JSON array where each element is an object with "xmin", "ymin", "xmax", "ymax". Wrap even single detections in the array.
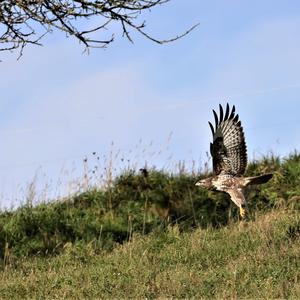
[{"xmin": 196, "ymin": 103, "xmax": 273, "ymax": 218}]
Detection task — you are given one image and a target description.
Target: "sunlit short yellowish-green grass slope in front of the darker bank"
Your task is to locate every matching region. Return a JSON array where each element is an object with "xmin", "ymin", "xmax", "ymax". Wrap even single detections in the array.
[{"xmin": 0, "ymin": 209, "xmax": 300, "ymax": 299}]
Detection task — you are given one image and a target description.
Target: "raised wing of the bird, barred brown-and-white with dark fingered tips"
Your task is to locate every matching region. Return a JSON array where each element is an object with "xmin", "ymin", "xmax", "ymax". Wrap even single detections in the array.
[{"xmin": 208, "ymin": 103, "xmax": 247, "ymax": 176}]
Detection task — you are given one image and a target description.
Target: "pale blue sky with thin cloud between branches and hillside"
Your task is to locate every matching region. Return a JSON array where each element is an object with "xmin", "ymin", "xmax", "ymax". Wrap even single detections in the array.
[{"xmin": 0, "ymin": 0, "xmax": 300, "ymax": 206}]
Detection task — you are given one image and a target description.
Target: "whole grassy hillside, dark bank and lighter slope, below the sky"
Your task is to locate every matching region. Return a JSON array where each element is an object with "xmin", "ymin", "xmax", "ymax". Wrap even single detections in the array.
[{"xmin": 0, "ymin": 153, "xmax": 300, "ymax": 299}]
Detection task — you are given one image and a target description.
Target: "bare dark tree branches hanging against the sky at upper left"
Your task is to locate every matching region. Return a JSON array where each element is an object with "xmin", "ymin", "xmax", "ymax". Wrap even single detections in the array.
[{"xmin": 0, "ymin": 0, "xmax": 198, "ymax": 56}]
